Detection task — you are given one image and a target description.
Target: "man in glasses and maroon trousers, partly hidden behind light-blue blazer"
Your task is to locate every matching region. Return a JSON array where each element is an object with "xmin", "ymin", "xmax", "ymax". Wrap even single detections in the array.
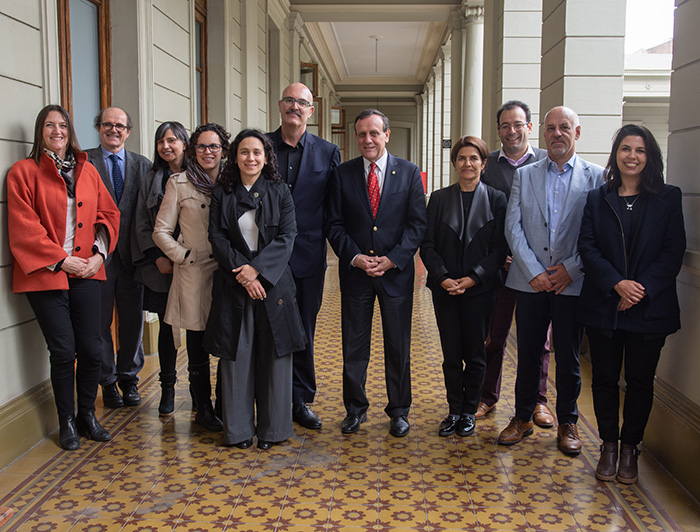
[{"xmin": 476, "ymin": 100, "xmax": 554, "ymax": 427}]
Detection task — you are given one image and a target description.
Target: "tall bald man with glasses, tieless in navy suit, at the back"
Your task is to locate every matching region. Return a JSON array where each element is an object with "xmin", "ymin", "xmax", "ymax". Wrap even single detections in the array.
[{"xmin": 268, "ymin": 83, "xmax": 340, "ymax": 429}]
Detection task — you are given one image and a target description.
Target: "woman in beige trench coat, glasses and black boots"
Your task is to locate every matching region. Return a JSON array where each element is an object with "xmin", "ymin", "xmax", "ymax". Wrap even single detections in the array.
[{"xmin": 153, "ymin": 124, "xmax": 230, "ymax": 431}]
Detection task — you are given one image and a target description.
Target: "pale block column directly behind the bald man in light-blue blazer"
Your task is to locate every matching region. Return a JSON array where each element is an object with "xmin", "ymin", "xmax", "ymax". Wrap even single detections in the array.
[{"xmin": 540, "ymin": 0, "xmax": 625, "ymax": 165}]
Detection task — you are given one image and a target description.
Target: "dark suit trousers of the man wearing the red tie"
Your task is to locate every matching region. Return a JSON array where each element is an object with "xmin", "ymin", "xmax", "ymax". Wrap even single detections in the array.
[{"xmin": 341, "ymin": 278, "xmax": 413, "ymax": 417}]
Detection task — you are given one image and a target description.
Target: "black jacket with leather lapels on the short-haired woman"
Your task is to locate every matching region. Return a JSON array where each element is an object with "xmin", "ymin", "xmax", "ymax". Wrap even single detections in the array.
[{"xmin": 420, "ymin": 182, "xmax": 508, "ymax": 297}]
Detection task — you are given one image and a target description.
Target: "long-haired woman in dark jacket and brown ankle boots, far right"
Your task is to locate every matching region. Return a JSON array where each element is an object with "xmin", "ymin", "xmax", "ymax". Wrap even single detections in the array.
[{"xmin": 578, "ymin": 124, "xmax": 685, "ymax": 484}]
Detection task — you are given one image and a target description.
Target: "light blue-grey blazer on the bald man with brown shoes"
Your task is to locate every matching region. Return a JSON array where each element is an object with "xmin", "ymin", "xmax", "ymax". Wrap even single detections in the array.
[{"xmin": 505, "ymin": 157, "xmax": 603, "ymax": 296}]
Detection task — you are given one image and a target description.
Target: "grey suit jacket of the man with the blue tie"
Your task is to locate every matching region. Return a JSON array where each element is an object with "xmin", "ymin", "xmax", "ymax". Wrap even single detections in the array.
[{"xmin": 85, "ymin": 146, "xmax": 152, "ymax": 270}]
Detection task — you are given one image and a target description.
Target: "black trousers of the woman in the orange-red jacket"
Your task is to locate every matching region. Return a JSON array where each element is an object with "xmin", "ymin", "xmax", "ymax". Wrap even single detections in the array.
[{"xmin": 27, "ymin": 272, "xmax": 102, "ymax": 416}]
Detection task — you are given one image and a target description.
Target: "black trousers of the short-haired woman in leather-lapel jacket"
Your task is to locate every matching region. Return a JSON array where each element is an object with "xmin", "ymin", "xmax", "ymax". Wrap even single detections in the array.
[{"xmin": 433, "ymin": 288, "xmax": 494, "ymax": 415}]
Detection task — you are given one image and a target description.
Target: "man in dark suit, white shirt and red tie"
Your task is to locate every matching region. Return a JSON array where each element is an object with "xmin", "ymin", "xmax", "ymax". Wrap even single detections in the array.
[{"xmin": 328, "ymin": 109, "xmax": 427, "ymax": 437}]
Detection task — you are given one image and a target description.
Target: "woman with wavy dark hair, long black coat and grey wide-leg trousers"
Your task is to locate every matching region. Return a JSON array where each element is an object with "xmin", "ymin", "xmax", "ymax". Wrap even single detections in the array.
[{"xmin": 205, "ymin": 129, "xmax": 306, "ymax": 449}]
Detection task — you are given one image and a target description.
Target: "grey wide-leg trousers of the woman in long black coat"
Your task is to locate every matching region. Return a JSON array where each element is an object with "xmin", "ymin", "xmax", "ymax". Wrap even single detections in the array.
[{"xmin": 221, "ymin": 300, "xmax": 294, "ymax": 445}]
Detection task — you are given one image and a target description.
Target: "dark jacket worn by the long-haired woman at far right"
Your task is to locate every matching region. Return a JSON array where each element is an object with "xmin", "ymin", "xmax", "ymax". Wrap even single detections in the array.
[{"xmin": 578, "ymin": 185, "xmax": 685, "ymax": 334}]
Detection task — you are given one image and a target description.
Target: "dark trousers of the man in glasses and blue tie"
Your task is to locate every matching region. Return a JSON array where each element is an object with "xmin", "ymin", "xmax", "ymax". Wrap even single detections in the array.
[{"xmin": 100, "ymin": 251, "xmax": 145, "ymax": 386}]
